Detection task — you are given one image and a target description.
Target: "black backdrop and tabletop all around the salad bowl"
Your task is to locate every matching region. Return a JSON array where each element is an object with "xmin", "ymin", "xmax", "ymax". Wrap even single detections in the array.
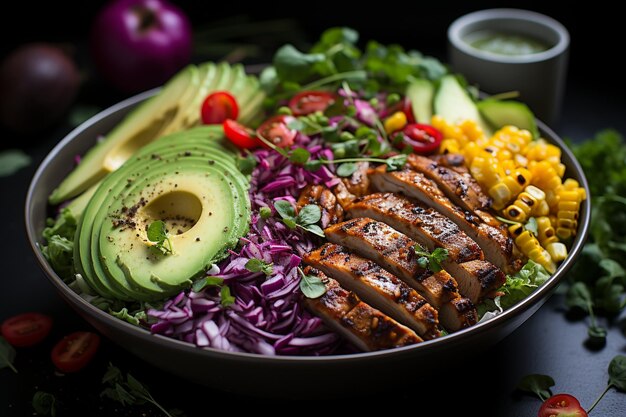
[{"xmin": 0, "ymin": 1, "xmax": 626, "ymax": 417}]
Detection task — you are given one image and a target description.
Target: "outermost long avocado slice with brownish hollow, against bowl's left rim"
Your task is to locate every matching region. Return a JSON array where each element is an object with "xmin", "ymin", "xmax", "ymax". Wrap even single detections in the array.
[{"xmin": 49, "ymin": 66, "xmax": 198, "ymax": 204}]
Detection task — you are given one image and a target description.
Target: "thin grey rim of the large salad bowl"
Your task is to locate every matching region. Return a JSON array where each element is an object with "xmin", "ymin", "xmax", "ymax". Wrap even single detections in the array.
[{"xmin": 24, "ymin": 88, "xmax": 591, "ymax": 364}]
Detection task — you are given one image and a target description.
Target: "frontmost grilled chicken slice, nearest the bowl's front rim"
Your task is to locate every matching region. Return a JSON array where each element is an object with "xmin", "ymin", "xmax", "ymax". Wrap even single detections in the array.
[{"xmin": 304, "ymin": 266, "xmax": 423, "ymax": 351}]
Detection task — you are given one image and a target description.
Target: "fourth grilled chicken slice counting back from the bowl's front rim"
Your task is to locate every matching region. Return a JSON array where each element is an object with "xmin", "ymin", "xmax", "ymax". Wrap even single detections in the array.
[{"xmin": 346, "ymin": 193, "xmax": 483, "ymax": 262}]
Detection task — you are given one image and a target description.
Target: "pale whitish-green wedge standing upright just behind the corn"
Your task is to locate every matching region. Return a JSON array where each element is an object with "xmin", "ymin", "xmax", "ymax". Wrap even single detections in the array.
[{"xmin": 434, "ymin": 75, "xmax": 492, "ymax": 136}]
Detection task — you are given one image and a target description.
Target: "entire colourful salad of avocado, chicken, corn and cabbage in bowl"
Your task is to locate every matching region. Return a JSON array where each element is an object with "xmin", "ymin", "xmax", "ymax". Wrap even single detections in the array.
[{"xmin": 40, "ymin": 28, "xmax": 587, "ymax": 356}]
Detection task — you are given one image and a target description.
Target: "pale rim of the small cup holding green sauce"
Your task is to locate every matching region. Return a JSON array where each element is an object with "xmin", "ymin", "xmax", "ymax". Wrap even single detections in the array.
[{"xmin": 448, "ymin": 8, "xmax": 570, "ymax": 64}]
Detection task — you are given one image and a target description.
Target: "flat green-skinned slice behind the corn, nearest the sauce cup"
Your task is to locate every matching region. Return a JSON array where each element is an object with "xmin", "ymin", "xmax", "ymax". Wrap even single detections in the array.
[{"xmin": 476, "ymin": 99, "xmax": 539, "ymax": 138}]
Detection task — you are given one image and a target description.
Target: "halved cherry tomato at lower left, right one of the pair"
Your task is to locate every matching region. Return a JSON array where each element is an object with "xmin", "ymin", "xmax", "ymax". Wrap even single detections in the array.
[{"xmin": 51, "ymin": 332, "xmax": 100, "ymax": 373}]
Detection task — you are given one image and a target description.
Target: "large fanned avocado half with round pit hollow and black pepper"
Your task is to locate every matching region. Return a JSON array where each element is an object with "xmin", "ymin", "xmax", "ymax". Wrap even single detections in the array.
[{"xmin": 74, "ymin": 126, "xmax": 250, "ymax": 301}]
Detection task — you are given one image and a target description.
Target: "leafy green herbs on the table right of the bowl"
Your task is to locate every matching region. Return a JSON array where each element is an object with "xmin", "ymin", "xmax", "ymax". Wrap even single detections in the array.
[{"xmin": 567, "ymin": 130, "xmax": 626, "ymax": 341}]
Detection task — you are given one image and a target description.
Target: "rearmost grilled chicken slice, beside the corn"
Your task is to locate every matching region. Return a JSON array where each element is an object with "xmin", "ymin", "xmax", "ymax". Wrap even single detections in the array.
[{"xmin": 407, "ymin": 154, "xmax": 490, "ymax": 212}]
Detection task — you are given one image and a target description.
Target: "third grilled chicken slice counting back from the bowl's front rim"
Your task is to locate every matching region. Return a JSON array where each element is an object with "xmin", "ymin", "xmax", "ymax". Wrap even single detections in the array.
[{"xmin": 324, "ymin": 217, "xmax": 458, "ymax": 308}]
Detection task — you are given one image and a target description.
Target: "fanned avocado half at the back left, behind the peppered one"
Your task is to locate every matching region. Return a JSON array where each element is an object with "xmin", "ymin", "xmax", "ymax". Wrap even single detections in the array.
[{"xmin": 49, "ymin": 63, "xmax": 265, "ymax": 205}]
